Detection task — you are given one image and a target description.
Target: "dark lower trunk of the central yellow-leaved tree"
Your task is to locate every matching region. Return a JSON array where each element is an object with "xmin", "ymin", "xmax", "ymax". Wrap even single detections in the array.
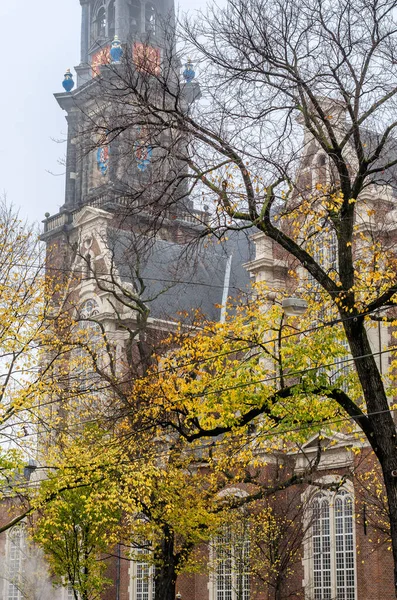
[{"xmin": 154, "ymin": 526, "xmax": 177, "ymax": 600}]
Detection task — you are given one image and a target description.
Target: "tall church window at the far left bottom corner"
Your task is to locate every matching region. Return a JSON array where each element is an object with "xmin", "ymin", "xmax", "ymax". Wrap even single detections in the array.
[{"xmin": 5, "ymin": 524, "xmax": 25, "ymax": 600}]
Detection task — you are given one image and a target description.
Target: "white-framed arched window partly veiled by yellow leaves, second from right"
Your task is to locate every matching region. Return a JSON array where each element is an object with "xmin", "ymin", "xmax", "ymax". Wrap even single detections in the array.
[{"xmin": 212, "ymin": 527, "xmax": 250, "ymax": 600}]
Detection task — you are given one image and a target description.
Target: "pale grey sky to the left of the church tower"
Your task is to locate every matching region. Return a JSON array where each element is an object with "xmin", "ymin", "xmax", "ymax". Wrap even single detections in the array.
[{"xmin": 0, "ymin": 0, "xmax": 205, "ymax": 221}]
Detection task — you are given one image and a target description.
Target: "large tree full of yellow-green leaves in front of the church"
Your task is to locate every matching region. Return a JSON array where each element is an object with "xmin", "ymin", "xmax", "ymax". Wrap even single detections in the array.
[{"xmin": 35, "ymin": 287, "xmax": 359, "ymax": 600}]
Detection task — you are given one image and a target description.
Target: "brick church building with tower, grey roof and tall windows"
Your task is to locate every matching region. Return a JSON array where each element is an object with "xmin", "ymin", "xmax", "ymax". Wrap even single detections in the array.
[{"xmin": 0, "ymin": 0, "xmax": 395, "ymax": 600}]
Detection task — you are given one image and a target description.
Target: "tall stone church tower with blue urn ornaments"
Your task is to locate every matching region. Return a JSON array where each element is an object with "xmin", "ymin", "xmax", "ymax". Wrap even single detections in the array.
[{"xmin": 43, "ymin": 0, "xmax": 201, "ymax": 240}]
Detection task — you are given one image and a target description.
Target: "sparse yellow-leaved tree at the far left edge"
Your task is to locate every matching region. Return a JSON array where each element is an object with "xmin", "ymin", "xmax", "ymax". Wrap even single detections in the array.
[{"xmin": 0, "ymin": 198, "xmax": 70, "ymax": 531}]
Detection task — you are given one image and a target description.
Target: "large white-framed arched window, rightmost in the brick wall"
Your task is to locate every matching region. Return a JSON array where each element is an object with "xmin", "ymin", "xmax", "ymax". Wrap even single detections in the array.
[{"xmin": 306, "ymin": 489, "xmax": 356, "ymax": 600}]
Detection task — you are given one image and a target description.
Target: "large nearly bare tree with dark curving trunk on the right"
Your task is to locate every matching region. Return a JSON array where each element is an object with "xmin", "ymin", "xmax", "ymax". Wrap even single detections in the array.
[{"xmin": 66, "ymin": 0, "xmax": 397, "ymax": 593}]
